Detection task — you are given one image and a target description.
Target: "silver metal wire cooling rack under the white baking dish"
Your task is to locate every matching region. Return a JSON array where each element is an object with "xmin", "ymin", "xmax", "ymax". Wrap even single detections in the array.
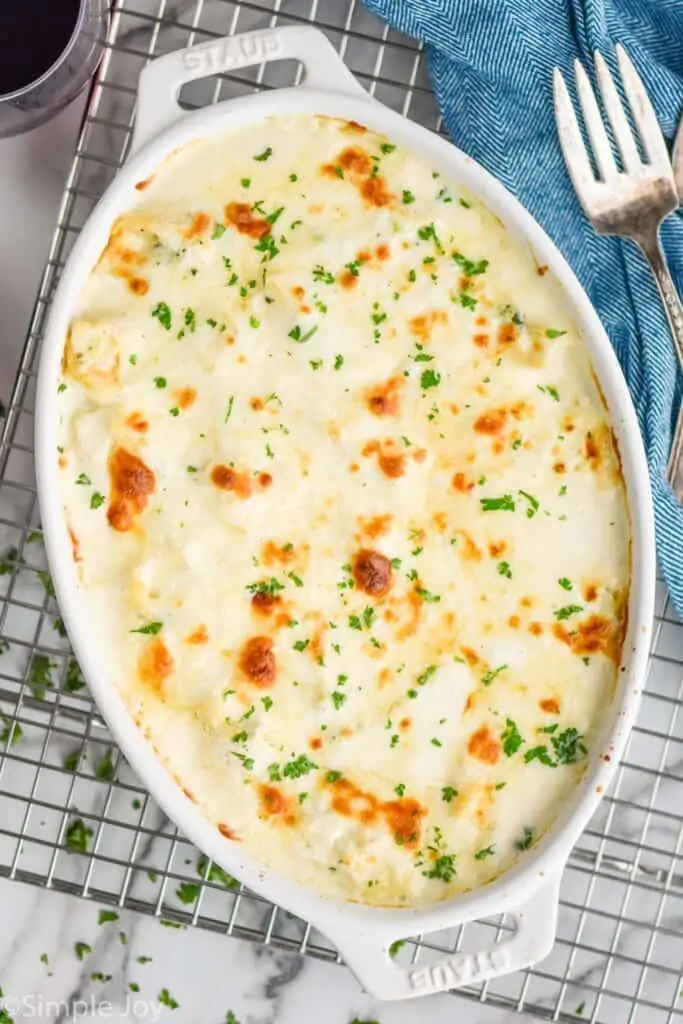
[{"xmin": 0, "ymin": 0, "xmax": 683, "ymax": 1024}]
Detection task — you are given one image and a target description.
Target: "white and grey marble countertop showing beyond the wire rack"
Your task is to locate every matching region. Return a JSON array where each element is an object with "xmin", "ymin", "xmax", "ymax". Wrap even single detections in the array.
[{"xmin": 0, "ymin": 86, "xmax": 530, "ymax": 1024}]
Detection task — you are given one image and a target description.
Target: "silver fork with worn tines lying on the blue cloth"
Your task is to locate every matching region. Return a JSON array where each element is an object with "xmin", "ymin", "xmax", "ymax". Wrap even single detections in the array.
[{"xmin": 554, "ymin": 44, "xmax": 683, "ymax": 501}]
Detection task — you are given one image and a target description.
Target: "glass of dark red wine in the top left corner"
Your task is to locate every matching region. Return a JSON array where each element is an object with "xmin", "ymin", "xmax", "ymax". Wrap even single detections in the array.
[{"xmin": 0, "ymin": 0, "xmax": 109, "ymax": 137}]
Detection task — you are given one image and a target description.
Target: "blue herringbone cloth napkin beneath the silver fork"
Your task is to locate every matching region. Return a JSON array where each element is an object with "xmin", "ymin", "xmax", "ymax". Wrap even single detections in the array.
[{"xmin": 366, "ymin": 0, "xmax": 683, "ymax": 614}]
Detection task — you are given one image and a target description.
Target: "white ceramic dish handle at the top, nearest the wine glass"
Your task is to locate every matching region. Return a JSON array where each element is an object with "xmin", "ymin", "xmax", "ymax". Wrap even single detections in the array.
[{"xmin": 132, "ymin": 26, "xmax": 368, "ymax": 152}]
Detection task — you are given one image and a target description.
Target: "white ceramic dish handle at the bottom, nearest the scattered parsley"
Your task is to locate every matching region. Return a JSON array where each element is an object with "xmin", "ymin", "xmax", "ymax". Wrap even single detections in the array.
[{"xmin": 327, "ymin": 871, "xmax": 562, "ymax": 999}]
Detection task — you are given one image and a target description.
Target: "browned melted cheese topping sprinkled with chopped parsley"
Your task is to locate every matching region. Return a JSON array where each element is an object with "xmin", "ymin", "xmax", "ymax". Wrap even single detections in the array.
[{"xmin": 58, "ymin": 117, "xmax": 629, "ymax": 905}]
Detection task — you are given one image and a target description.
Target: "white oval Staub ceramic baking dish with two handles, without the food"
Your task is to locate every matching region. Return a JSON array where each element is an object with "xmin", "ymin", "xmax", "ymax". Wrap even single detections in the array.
[{"xmin": 36, "ymin": 28, "xmax": 655, "ymax": 999}]
